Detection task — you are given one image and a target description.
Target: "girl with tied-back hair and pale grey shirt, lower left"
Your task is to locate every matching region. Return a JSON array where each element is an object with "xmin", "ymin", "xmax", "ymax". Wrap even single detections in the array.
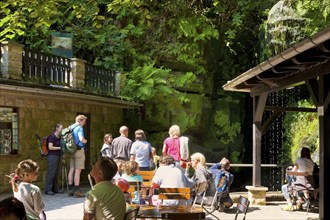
[{"xmin": 10, "ymin": 159, "xmax": 46, "ymax": 219}]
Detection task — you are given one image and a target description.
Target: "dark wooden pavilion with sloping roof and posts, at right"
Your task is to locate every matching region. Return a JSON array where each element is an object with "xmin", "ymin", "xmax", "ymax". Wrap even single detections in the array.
[{"xmin": 223, "ymin": 28, "xmax": 330, "ymax": 220}]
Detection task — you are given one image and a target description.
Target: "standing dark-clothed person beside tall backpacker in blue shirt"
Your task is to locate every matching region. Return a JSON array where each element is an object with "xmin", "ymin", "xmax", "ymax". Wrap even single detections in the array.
[{"xmin": 45, "ymin": 124, "xmax": 63, "ymax": 195}]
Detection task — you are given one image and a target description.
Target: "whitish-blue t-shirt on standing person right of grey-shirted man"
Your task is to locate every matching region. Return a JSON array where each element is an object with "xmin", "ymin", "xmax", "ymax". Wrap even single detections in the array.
[{"xmin": 130, "ymin": 141, "xmax": 151, "ymax": 167}]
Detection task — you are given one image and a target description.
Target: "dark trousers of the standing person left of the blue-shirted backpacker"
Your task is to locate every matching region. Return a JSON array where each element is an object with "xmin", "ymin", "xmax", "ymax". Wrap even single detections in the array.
[{"xmin": 45, "ymin": 155, "xmax": 61, "ymax": 192}]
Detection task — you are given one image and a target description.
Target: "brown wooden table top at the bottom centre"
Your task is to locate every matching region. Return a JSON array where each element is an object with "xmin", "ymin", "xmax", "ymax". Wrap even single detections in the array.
[{"xmin": 127, "ymin": 204, "xmax": 205, "ymax": 220}]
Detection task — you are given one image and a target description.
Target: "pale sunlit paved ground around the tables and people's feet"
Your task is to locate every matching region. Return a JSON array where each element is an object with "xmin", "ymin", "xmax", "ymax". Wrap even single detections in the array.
[{"xmin": 1, "ymin": 188, "xmax": 319, "ymax": 220}]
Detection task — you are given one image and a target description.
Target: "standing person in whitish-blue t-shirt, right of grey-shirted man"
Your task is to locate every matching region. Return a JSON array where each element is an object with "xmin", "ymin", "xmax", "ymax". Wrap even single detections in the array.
[{"xmin": 130, "ymin": 129, "xmax": 154, "ymax": 171}]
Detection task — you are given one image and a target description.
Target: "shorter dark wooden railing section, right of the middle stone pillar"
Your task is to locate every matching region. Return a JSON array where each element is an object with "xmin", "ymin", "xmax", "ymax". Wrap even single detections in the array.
[{"xmin": 85, "ymin": 64, "xmax": 116, "ymax": 94}]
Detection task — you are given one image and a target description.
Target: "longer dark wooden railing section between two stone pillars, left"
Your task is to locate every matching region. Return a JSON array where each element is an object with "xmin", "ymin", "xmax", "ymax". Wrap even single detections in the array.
[{"xmin": 23, "ymin": 48, "xmax": 71, "ymax": 86}]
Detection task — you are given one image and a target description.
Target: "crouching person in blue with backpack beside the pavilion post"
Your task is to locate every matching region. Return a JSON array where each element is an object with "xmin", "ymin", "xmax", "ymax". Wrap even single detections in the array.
[{"xmin": 209, "ymin": 157, "xmax": 234, "ymax": 208}]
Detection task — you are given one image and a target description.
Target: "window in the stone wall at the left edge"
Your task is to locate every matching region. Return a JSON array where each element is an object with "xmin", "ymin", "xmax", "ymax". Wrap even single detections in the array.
[{"xmin": 0, "ymin": 106, "xmax": 18, "ymax": 154}]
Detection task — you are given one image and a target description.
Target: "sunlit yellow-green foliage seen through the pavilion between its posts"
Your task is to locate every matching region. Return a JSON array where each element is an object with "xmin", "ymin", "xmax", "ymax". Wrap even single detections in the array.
[{"xmin": 281, "ymin": 100, "xmax": 318, "ymax": 164}]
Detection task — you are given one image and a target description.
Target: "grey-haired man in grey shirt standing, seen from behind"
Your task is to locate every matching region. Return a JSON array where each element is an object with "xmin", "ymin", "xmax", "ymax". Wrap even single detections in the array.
[{"xmin": 112, "ymin": 126, "xmax": 132, "ymax": 161}]
